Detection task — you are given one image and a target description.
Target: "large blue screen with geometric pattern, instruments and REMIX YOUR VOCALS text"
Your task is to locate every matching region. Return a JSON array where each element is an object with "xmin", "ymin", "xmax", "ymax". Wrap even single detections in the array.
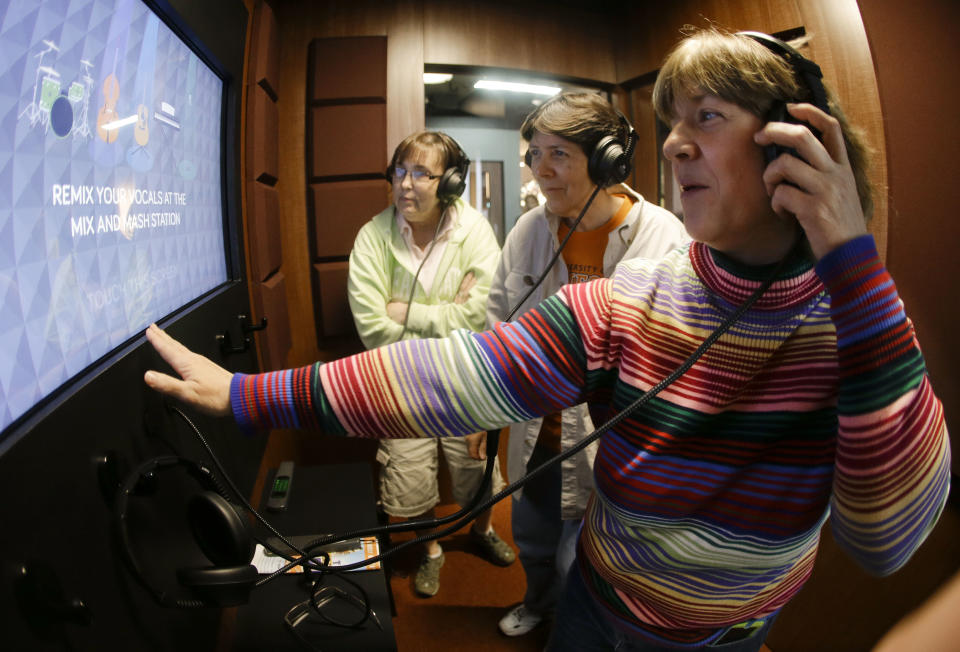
[{"xmin": 0, "ymin": 0, "xmax": 227, "ymax": 430}]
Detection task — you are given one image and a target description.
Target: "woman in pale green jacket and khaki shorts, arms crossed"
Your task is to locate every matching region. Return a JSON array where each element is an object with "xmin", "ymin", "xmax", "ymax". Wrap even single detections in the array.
[{"xmin": 348, "ymin": 131, "xmax": 516, "ymax": 597}]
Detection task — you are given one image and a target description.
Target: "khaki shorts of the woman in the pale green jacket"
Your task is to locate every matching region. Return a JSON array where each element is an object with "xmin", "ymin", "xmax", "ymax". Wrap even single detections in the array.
[{"xmin": 377, "ymin": 437, "xmax": 504, "ymax": 518}]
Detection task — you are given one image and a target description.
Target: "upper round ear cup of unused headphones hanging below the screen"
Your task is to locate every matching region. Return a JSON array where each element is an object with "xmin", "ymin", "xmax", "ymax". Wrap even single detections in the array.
[{"xmin": 187, "ymin": 491, "xmax": 253, "ymax": 566}]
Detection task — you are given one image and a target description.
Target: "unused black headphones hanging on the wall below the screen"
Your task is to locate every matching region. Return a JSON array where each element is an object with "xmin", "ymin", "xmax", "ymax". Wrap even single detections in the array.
[{"xmin": 114, "ymin": 455, "xmax": 259, "ymax": 608}]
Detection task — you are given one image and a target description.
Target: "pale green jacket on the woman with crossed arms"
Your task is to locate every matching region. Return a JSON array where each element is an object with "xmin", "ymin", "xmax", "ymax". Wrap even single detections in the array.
[{"xmin": 347, "ymin": 199, "xmax": 500, "ymax": 349}]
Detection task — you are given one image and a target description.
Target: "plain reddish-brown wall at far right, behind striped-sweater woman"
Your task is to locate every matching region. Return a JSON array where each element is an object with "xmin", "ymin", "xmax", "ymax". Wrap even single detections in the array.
[{"xmin": 861, "ymin": 0, "xmax": 960, "ymax": 473}]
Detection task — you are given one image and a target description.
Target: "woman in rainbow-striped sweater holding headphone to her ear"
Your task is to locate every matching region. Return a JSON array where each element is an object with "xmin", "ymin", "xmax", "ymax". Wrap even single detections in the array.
[{"xmin": 145, "ymin": 30, "xmax": 950, "ymax": 652}]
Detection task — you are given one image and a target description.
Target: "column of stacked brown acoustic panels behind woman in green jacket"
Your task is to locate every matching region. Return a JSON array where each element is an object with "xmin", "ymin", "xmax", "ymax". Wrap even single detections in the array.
[{"xmin": 306, "ymin": 36, "xmax": 390, "ymax": 350}]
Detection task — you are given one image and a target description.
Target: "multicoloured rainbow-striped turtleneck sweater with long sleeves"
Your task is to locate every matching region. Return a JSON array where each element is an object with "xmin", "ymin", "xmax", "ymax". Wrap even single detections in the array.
[{"xmin": 231, "ymin": 236, "xmax": 950, "ymax": 643}]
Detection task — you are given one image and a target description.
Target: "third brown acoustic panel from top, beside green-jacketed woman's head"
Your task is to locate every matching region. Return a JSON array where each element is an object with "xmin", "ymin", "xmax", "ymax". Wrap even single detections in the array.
[{"xmin": 310, "ymin": 180, "xmax": 391, "ymax": 258}]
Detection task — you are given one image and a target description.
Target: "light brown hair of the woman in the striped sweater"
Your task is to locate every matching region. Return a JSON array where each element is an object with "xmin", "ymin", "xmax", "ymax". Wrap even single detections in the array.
[{"xmin": 653, "ymin": 27, "xmax": 873, "ymax": 219}]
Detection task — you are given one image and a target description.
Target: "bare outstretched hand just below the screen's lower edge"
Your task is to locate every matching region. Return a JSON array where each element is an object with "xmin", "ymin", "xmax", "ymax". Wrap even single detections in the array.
[{"xmin": 143, "ymin": 324, "xmax": 233, "ymax": 416}]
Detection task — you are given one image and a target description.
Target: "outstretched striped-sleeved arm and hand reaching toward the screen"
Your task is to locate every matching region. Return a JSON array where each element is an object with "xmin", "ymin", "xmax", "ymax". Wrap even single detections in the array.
[{"xmin": 144, "ymin": 297, "xmax": 600, "ymax": 440}]
